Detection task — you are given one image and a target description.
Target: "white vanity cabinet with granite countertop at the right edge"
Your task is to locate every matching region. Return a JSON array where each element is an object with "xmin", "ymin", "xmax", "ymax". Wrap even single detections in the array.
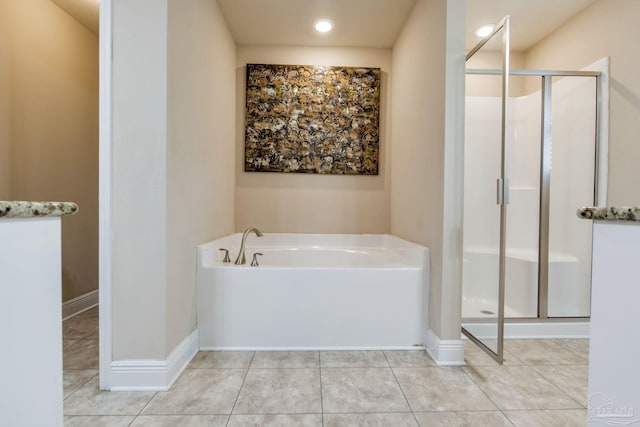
[{"xmin": 578, "ymin": 207, "xmax": 640, "ymax": 427}]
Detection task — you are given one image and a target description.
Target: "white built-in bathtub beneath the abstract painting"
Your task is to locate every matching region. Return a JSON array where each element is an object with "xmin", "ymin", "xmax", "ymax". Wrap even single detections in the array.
[{"xmin": 197, "ymin": 233, "xmax": 429, "ymax": 350}]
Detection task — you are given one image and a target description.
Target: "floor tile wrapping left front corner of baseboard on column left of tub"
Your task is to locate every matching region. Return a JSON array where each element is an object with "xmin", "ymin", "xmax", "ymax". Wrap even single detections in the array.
[{"xmin": 64, "ymin": 377, "xmax": 155, "ymax": 415}]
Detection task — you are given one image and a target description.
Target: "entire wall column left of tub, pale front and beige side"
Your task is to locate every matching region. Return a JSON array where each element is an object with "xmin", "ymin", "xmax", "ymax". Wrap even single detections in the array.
[{"xmin": 112, "ymin": 0, "xmax": 235, "ymax": 360}]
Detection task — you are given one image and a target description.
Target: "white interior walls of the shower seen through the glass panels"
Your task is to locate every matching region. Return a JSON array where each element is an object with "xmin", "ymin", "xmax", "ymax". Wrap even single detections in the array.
[{"xmin": 463, "ymin": 76, "xmax": 595, "ymax": 317}]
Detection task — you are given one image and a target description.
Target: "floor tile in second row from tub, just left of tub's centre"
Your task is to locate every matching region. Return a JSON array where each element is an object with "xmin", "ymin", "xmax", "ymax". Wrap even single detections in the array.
[{"xmin": 233, "ymin": 369, "xmax": 322, "ymax": 414}]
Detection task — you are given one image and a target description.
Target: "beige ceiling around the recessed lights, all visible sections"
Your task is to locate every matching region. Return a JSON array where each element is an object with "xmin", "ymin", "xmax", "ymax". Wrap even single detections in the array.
[{"xmin": 51, "ymin": 0, "xmax": 598, "ymax": 51}]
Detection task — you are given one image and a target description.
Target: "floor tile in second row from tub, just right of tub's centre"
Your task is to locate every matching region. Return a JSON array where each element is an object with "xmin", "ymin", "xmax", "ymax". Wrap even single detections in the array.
[{"xmin": 322, "ymin": 368, "xmax": 410, "ymax": 414}]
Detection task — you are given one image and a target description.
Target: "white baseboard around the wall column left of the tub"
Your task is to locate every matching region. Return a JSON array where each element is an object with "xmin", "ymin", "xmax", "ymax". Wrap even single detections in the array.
[{"xmin": 110, "ymin": 330, "xmax": 198, "ymax": 391}]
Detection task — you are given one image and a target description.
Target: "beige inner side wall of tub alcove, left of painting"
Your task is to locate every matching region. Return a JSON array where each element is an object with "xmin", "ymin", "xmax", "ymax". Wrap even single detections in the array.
[{"xmin": 166, "ymin": 0, "xmax": 236, "ymax": 350}]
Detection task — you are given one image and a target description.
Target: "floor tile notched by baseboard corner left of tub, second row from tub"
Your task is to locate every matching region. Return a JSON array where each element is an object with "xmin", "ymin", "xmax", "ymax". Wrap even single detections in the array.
[{"xmin": 144, "ymin": 369, "xmax": 246, "ymax": 415}]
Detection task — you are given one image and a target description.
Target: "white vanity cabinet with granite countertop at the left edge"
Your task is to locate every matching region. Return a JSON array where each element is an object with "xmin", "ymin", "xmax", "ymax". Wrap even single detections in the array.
[{"xmin": 0, "ymin": 202, "xmax": 77, "ymax": 427}]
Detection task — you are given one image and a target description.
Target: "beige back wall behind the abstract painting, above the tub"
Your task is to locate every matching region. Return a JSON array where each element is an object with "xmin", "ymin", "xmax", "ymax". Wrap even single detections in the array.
[{"xmin": 236, "ymin": 46, "xmax": 391, "ymax": 233}]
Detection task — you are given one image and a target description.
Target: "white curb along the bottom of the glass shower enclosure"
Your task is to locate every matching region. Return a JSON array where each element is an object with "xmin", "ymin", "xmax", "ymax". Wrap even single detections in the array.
[{"xmin": 463, "ymin": 322, "xmax": 589, "ymax": 340}]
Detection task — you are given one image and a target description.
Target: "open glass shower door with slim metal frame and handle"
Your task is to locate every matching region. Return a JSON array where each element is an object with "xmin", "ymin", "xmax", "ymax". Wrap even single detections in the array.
[{"xmin": 462, "ymin": 16, "xmax": 509, "ymax": 363}]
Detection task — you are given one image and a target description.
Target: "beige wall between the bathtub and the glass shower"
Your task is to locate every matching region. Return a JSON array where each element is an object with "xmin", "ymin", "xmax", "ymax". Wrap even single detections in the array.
[{"xmin": 391, "ymin": 0, "xmax": 464, "ymax": 339}]
